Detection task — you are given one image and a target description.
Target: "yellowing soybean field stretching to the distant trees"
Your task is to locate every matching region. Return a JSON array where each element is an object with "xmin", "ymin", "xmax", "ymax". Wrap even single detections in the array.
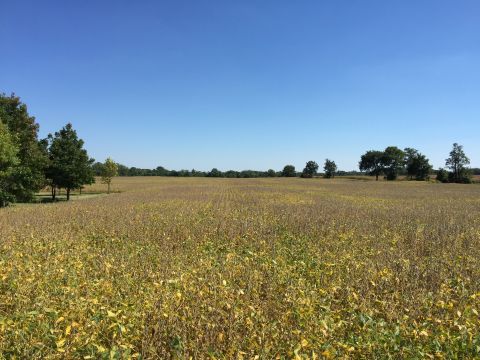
[{"xmin": 0, "ymin": 177, "xmax": 480, "ymax": 359}]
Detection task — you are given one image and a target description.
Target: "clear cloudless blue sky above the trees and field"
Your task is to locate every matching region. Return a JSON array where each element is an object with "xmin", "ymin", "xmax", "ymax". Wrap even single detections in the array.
[{"xmin": 0, "ymin": 0, "xmax": 480, "ymax": 170}]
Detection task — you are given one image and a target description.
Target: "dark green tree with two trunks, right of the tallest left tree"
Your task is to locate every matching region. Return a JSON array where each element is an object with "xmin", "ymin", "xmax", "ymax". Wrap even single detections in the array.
[{"xmin": 47, "ymin": 124, "xmax": 95, "ymax": 201}]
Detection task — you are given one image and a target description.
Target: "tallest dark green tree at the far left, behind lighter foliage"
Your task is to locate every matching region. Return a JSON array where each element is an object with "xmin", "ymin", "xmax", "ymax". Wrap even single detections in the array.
[{"xmin": 0, "ymin": 94, "xmax": 48, "ymax": 201}]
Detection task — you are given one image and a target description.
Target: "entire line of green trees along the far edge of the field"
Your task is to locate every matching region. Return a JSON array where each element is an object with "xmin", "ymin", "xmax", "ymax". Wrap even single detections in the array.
[{"xmin": 0, "ymin": 94, "xmax": 480, "ymax": 207}]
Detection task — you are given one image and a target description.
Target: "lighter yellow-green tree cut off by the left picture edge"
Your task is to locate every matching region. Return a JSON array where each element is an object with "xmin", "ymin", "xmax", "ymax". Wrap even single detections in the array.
[{"xmin": 0, "ymin": 121, "xmax": 19, "ymax": 207}]
